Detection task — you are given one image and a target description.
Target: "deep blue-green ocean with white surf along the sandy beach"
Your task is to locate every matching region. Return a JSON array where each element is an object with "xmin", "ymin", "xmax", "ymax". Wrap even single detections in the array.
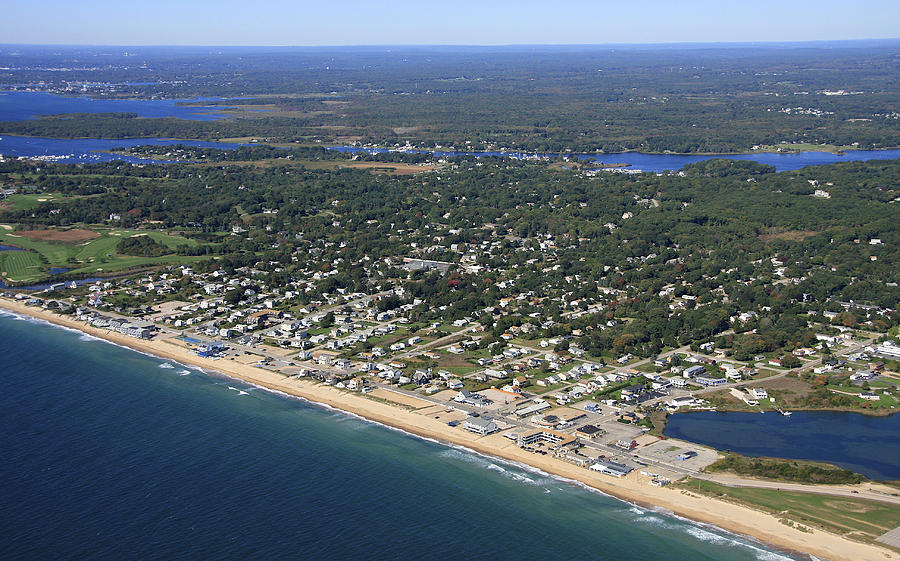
[{"xmin": 0, "ymin": 312, "xmax": 800, "ymax": 561}]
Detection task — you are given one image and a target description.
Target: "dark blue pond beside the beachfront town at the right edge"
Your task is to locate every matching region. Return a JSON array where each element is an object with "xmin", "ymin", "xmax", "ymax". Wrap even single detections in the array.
[{"xmin": 665, "ymin": 411, "xmax": 900, "ymax": 480}]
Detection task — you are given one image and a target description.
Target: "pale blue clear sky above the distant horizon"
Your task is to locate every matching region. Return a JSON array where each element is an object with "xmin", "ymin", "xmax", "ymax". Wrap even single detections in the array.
[{"xmin": 0, "ymin": 0, "xmax": 900, "ymax": 46}]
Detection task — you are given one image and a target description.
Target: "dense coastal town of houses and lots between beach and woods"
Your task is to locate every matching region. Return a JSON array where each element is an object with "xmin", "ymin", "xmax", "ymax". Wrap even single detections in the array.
[{"xmin": 3, "ymin": 245, "xmax": 900, "ymax": 498}]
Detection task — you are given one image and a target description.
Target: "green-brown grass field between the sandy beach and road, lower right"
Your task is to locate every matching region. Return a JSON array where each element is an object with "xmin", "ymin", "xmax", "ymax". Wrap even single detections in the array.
[{"xmin": 682, "ymin": 479, "xmax": 900, "ymax": 540}]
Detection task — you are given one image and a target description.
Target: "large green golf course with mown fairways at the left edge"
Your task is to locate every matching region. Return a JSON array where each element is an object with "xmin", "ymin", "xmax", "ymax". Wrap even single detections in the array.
[{"xmin": 0, "ymin": 228, "xmax": 213, "ymax": 282}]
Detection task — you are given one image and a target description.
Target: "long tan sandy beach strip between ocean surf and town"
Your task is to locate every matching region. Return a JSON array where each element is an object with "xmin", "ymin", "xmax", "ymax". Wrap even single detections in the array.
[{"xmin": 0, "ymin": 298, "xmax": 896, "ymax": 561}]
